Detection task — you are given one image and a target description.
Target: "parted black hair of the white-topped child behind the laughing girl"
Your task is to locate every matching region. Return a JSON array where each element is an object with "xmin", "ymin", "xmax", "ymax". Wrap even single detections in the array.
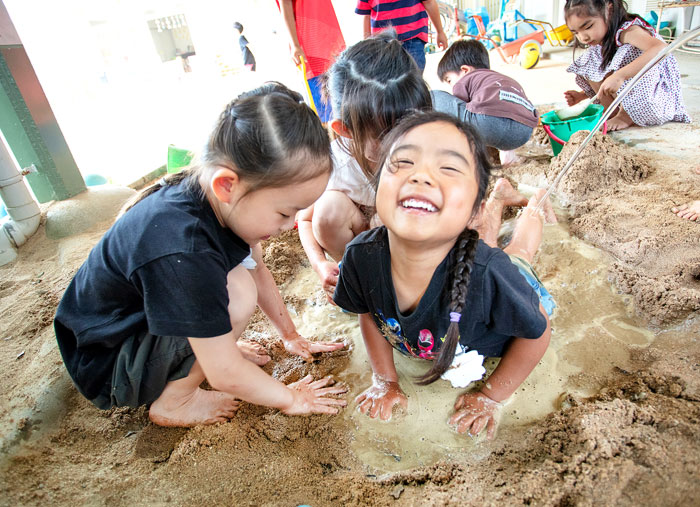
[{"xmin": 323, "ymin": 30, "xmax": 433, "ymax": 180}]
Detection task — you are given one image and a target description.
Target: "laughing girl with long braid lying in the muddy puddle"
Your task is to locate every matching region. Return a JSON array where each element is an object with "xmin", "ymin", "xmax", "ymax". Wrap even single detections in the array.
[{"xmin": 334, "ymin": 112, "xmax": 552, "ymax": 438}]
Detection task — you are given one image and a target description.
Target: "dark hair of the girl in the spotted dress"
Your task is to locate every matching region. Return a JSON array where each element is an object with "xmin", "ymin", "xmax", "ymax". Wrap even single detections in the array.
[{"xmin": 564, "ymin": 0, "xmax": 639, "ymax": 70}]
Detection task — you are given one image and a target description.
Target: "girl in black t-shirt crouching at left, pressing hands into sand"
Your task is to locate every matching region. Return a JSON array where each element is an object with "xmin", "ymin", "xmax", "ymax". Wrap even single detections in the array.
[{"xmin": 54, "ymin": 83, "xmax": 345, "ymax": 426}]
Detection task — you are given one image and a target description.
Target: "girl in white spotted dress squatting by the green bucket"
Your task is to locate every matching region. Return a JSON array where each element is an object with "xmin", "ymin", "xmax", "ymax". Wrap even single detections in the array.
[{"xmin": 564, "ymin": 0, "xmax": 690, "ymax": 130}]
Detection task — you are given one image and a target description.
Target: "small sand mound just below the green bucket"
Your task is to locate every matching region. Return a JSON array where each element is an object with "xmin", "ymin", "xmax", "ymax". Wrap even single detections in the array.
[{"xmin": 545, "ymin": 131, "xmax": 653, "ymax": 203}]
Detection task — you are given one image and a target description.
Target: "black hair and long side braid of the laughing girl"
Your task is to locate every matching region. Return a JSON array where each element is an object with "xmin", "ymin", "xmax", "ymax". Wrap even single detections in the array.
[{"xmin": 377, "ymin": 111, "xmax": 491, "ymax": 385}]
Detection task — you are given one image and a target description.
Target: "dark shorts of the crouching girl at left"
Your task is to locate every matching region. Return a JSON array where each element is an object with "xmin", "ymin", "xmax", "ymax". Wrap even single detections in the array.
[{"xmin": 90, "ymin": 333, "xmax": 195, "ymax": 410}]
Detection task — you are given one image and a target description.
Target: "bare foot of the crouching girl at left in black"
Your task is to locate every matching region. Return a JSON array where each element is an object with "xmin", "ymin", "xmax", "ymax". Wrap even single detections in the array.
[{"xmin": 148, "ymin": 385, "xmax": 239, "ymax": 427}]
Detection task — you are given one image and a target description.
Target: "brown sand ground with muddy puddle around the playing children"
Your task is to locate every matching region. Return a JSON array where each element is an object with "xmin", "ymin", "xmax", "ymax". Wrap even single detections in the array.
[{"xmin": 0, "ymin": 129, "xmax": 700, "ymax": 506}]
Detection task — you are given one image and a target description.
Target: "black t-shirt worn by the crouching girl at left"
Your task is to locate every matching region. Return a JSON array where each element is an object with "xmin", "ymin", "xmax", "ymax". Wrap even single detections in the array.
[{"xmin": 54, "ymin": 183, "xmax": 250, "ymax": 399}]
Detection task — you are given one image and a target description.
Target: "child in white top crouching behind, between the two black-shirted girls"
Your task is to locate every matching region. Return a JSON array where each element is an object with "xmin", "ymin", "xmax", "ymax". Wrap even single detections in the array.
[{"xmin": 297, "ymin": 31, "xmax": 431, "ymax": 298}]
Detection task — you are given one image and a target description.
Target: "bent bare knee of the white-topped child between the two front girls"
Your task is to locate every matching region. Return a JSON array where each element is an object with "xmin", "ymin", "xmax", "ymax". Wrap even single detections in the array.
[{"xmin": 312, "ymin": 190, "xmax": 369, "ymax": 261}]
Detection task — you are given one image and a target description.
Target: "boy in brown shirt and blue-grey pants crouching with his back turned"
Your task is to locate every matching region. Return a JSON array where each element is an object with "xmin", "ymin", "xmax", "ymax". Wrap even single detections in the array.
[{"xmin": 432, "ymin": 40, "xmax": 538, "ymax": 157}]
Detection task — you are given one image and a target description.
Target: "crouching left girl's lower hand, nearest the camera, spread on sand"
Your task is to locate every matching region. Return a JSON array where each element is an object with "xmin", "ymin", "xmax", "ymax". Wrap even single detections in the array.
[{"xmin": 282, "ymin": 375, "xmax": 348, "ymax": 415}]
